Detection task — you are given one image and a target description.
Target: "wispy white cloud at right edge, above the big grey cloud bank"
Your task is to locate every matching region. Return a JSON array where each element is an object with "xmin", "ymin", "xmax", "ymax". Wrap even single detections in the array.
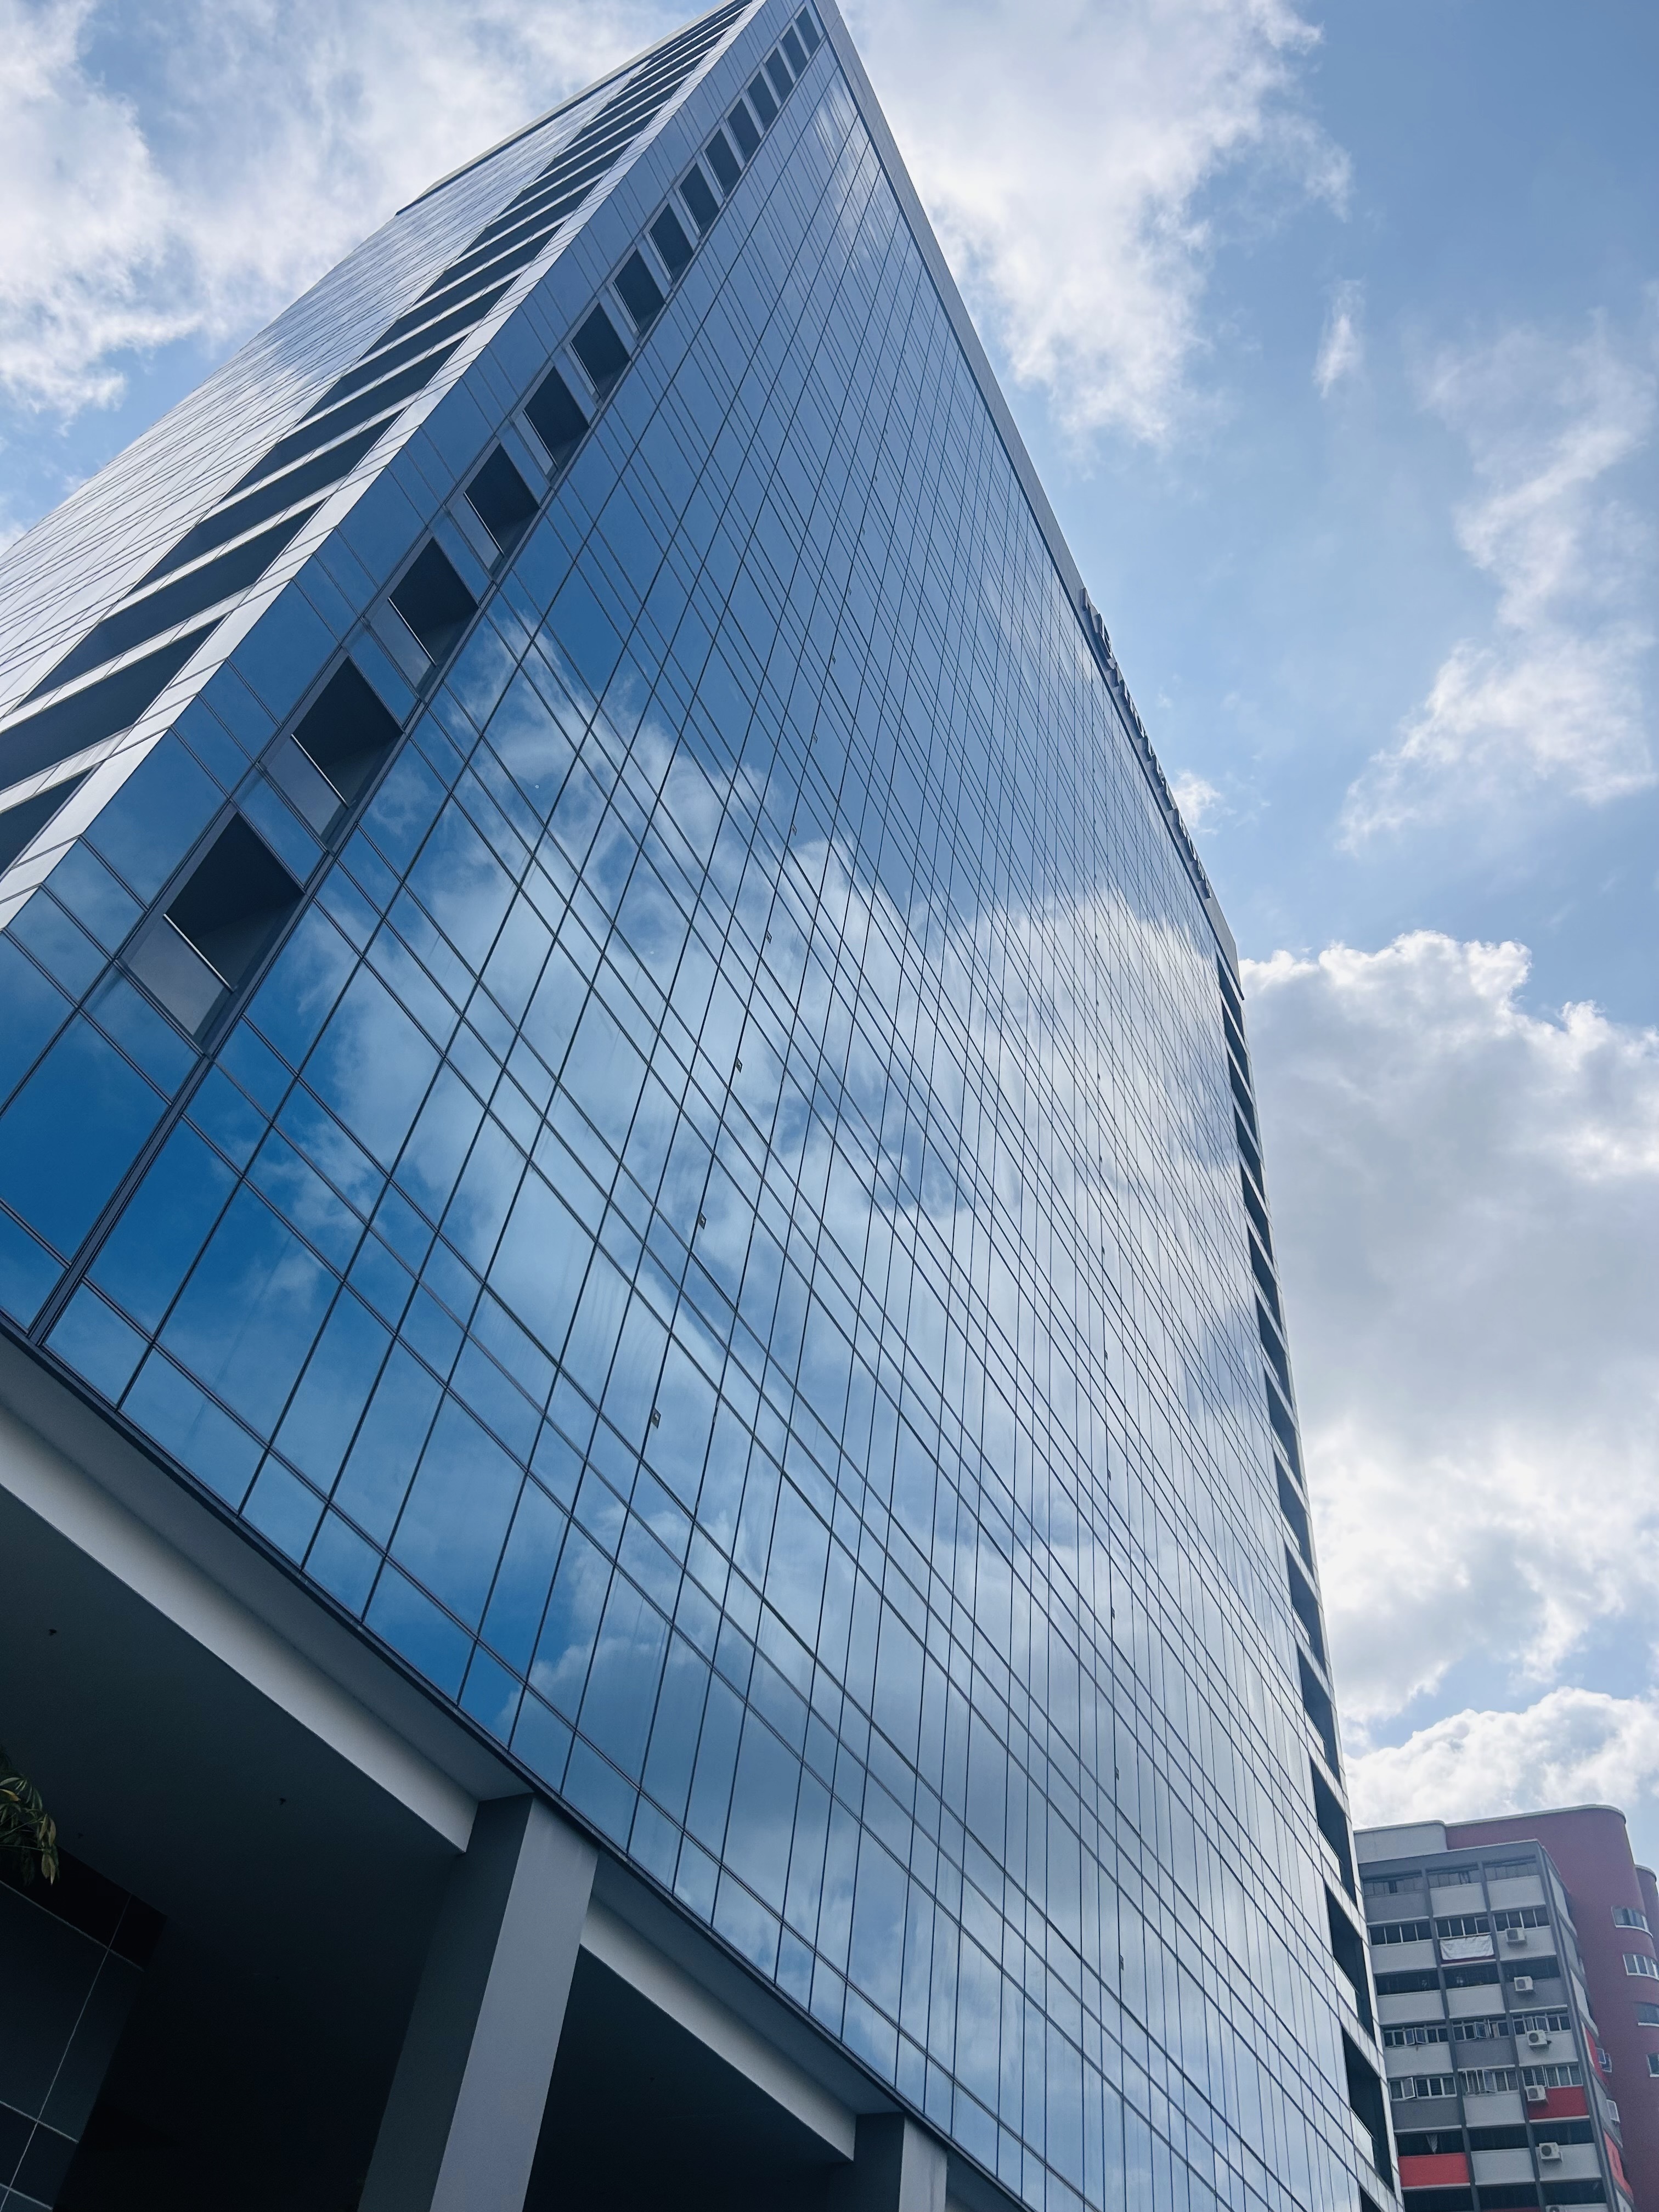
[{"xmin": 1342, "ymin": 328, "xmax": 1659, "ymax": 845}]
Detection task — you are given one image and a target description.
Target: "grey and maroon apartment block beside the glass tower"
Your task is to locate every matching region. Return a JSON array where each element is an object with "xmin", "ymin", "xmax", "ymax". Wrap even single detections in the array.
[{"xmin": 1356, "ymin": 1805, "xmax": 1659, "ymax": 2212}]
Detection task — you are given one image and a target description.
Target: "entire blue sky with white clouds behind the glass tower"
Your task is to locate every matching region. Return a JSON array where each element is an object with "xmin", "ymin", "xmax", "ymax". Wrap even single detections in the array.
[{"xmin": 0, "ymin": 0, "xmax": 1659, "ymax": 1856}]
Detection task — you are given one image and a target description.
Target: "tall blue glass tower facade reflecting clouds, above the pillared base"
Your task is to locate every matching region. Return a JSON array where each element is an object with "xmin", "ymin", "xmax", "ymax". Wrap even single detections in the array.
[{"xmin": 0, "ymin": 0, "xmax": 1393, "ymax": 2212}]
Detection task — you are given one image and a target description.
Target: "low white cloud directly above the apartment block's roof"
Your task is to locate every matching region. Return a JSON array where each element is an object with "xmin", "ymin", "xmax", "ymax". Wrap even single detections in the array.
[{"xmin": 1350, "ymin": 1690, "xmax": 1659, "ymax": 1827}]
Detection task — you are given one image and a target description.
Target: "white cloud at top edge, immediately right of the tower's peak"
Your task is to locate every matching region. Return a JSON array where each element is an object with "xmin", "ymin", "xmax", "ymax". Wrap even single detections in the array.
[{"xmin": 851, "ymin": 0, "xmax": 1347, "ymax": 442}]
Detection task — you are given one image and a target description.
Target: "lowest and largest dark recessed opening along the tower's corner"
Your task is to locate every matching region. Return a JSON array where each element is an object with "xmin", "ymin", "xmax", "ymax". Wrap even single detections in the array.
[{"xmin": 126, "ymin": 814, "xmax": 301, "ymax": 1035}]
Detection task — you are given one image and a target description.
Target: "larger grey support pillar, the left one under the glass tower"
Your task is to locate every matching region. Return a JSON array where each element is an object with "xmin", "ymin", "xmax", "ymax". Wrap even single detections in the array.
[{"xmin": 360, "ymin": 1796, "xmax": 595, "ymax": 2212}]
